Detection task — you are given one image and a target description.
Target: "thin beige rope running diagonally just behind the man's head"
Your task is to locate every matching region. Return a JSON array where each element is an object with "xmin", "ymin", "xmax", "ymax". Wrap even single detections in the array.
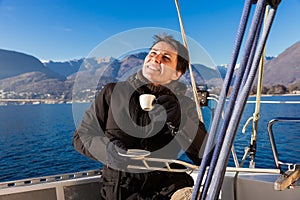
[{"xmin": 175, "ymin": 0, "xmax": 204, "ymax": 122}]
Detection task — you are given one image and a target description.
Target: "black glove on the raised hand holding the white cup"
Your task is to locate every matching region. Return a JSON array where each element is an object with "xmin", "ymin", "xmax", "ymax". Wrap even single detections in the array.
[{"xmin": 154, "ymin": 95, "xmax": 181, "ymax": 129}]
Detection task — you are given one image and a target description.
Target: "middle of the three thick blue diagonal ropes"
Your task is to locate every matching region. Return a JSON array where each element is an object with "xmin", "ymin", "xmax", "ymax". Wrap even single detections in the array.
[{"xmin": 201, "ymin": 0, "xmax": 266, "ymax": 200}]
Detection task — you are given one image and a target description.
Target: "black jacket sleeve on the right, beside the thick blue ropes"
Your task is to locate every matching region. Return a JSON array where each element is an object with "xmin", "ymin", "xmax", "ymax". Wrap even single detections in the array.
[{"xmin": 175, "ymin": 97, "xmax": 207, "ymax": 165}]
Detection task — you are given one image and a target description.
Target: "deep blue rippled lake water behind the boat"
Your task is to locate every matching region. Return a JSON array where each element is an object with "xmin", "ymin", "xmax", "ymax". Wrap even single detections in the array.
[{"xmin": 0, "ymin": 96, "xmax": 300, "ymax": 182}]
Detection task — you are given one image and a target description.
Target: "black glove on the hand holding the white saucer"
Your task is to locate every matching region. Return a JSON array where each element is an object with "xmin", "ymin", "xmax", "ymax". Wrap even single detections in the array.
[{"xmin": 106, "ymin": 139, "xmax": 129, "ymax": 170}]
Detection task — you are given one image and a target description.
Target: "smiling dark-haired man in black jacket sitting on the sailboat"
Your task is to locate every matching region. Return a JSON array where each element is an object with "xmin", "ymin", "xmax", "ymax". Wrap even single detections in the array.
[{"xmin": 73, "ymin": 34, "xmax": 207, "ymax": 200}]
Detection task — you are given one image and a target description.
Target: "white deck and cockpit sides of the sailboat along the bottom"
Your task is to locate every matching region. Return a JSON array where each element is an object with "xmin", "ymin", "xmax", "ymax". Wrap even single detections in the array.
[{"xmin": 0, "ymin": 171, "xmax": 300, "ymax": 200}]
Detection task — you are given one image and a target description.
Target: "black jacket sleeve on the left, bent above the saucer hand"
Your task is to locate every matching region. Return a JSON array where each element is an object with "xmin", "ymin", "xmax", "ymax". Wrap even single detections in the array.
[{"xmin": 72, "ymin": 86, "xmax": 110, "ymax": 162}]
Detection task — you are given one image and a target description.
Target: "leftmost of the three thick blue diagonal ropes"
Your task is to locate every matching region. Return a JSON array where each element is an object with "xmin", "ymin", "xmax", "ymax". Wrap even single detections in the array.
[{"xmin": 192, "ymin": 0, "xmax": 252, "ymax": 200}]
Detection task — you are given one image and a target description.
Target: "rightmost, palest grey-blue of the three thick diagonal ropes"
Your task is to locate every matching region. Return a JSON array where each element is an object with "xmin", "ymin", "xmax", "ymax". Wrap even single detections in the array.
[{"xmin": 208, "ymin": 4, "xmax": 276, "ymax": 199}]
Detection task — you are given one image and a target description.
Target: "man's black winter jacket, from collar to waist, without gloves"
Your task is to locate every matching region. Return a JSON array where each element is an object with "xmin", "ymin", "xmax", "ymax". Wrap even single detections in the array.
[{"xmin": 73, "ymin": 70, "xmax": 207, "ymax": 165}]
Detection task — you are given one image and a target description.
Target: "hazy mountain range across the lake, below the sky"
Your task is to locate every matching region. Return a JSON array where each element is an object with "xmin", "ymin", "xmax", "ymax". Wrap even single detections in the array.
[{"xmin": 0, "ymin": 42, "xmax": 300, "ymax": 99}]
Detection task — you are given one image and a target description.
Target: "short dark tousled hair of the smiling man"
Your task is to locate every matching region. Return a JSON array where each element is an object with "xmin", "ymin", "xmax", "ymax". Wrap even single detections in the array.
[{"xmin": 151, "ymin": 34, "xmax": 189, "ymax": 74}]
